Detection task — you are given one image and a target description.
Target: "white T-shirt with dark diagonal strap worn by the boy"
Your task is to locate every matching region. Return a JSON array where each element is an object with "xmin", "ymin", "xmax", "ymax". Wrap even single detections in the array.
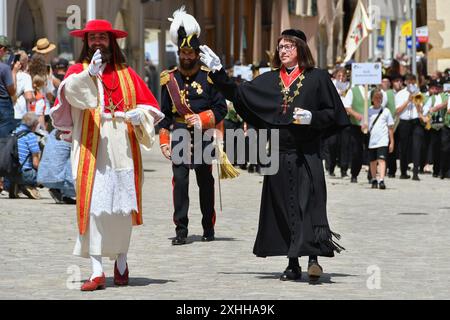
[{"xmin": 369, "ymin": 106, "xmax": 394, "ymax": 149}]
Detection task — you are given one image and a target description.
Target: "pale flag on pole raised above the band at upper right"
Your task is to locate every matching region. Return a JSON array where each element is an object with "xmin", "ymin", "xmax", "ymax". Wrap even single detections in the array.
[{"xmin": 344, "ymin": 0, "xmax": 372, "ymax": 62}]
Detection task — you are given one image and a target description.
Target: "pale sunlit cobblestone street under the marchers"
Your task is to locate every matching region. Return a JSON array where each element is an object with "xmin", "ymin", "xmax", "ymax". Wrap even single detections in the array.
[{"xmin": 0, "ymin": 147, "xmax": 450, "ymax": 300}]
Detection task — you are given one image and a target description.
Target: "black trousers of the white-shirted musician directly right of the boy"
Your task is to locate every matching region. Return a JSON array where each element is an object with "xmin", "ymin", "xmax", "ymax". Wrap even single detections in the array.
[{"xmin": 398, "ymin": 119, "xmax": 425, "ymax": 175}]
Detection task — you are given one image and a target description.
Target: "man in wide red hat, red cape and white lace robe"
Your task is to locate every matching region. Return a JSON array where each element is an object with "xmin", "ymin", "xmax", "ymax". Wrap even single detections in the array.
[{"xmin": 51, "ymin": 20, "xmax": 164, "ymax": 291}]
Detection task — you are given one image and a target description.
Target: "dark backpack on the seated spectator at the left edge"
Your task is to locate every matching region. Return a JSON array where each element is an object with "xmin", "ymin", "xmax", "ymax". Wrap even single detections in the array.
[{"xmin": 0, "ymin": 131, "xmax": 31, "ymax": 178}]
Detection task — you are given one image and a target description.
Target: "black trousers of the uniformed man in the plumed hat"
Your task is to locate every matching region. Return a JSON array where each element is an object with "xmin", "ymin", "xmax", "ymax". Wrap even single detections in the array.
[{"xmin": 172, "ymin": 165, "xmax": 216, "ymax": 237}]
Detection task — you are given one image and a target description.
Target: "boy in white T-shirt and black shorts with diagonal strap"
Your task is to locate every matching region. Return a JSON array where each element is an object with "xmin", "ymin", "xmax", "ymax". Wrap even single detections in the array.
[{"xmin": 369, "ymin": 89, "xmax": 394, "ymax": 190}]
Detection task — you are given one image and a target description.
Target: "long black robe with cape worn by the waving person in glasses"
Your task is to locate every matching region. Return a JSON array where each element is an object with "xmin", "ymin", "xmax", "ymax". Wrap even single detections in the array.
[{"xmin": 210, "ymin": 69, "xmax": 350, "ymax": 258}]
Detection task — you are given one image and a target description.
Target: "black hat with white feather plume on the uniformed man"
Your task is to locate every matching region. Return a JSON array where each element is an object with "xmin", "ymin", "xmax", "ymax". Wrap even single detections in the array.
[{"xmin": 169, "ymin": 6, "xmax": 201, "ymax": 50}]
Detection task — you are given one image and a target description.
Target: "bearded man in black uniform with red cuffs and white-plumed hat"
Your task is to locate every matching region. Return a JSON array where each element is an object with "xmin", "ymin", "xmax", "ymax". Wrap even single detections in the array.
[{"xmin": 160, "ymin": 9, "xmax": 227, "ymax": 245}]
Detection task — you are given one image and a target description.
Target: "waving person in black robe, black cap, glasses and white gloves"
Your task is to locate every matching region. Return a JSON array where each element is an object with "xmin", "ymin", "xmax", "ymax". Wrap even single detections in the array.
[{"xmin": 200, "ymin": 29, "xmax": 350, "ymax": 281}]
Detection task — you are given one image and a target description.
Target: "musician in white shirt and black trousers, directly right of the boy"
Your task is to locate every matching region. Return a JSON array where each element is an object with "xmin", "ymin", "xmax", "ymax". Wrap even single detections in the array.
[{"xmin": 395, "ymin": 74, "xmax": 425, "ymax": 181}]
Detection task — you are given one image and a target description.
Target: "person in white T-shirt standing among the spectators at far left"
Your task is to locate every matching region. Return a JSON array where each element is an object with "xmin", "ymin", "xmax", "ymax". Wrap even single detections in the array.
[{"xmin": 14, "ymin": 51, "xmax": 34, "ymax": 124}]
